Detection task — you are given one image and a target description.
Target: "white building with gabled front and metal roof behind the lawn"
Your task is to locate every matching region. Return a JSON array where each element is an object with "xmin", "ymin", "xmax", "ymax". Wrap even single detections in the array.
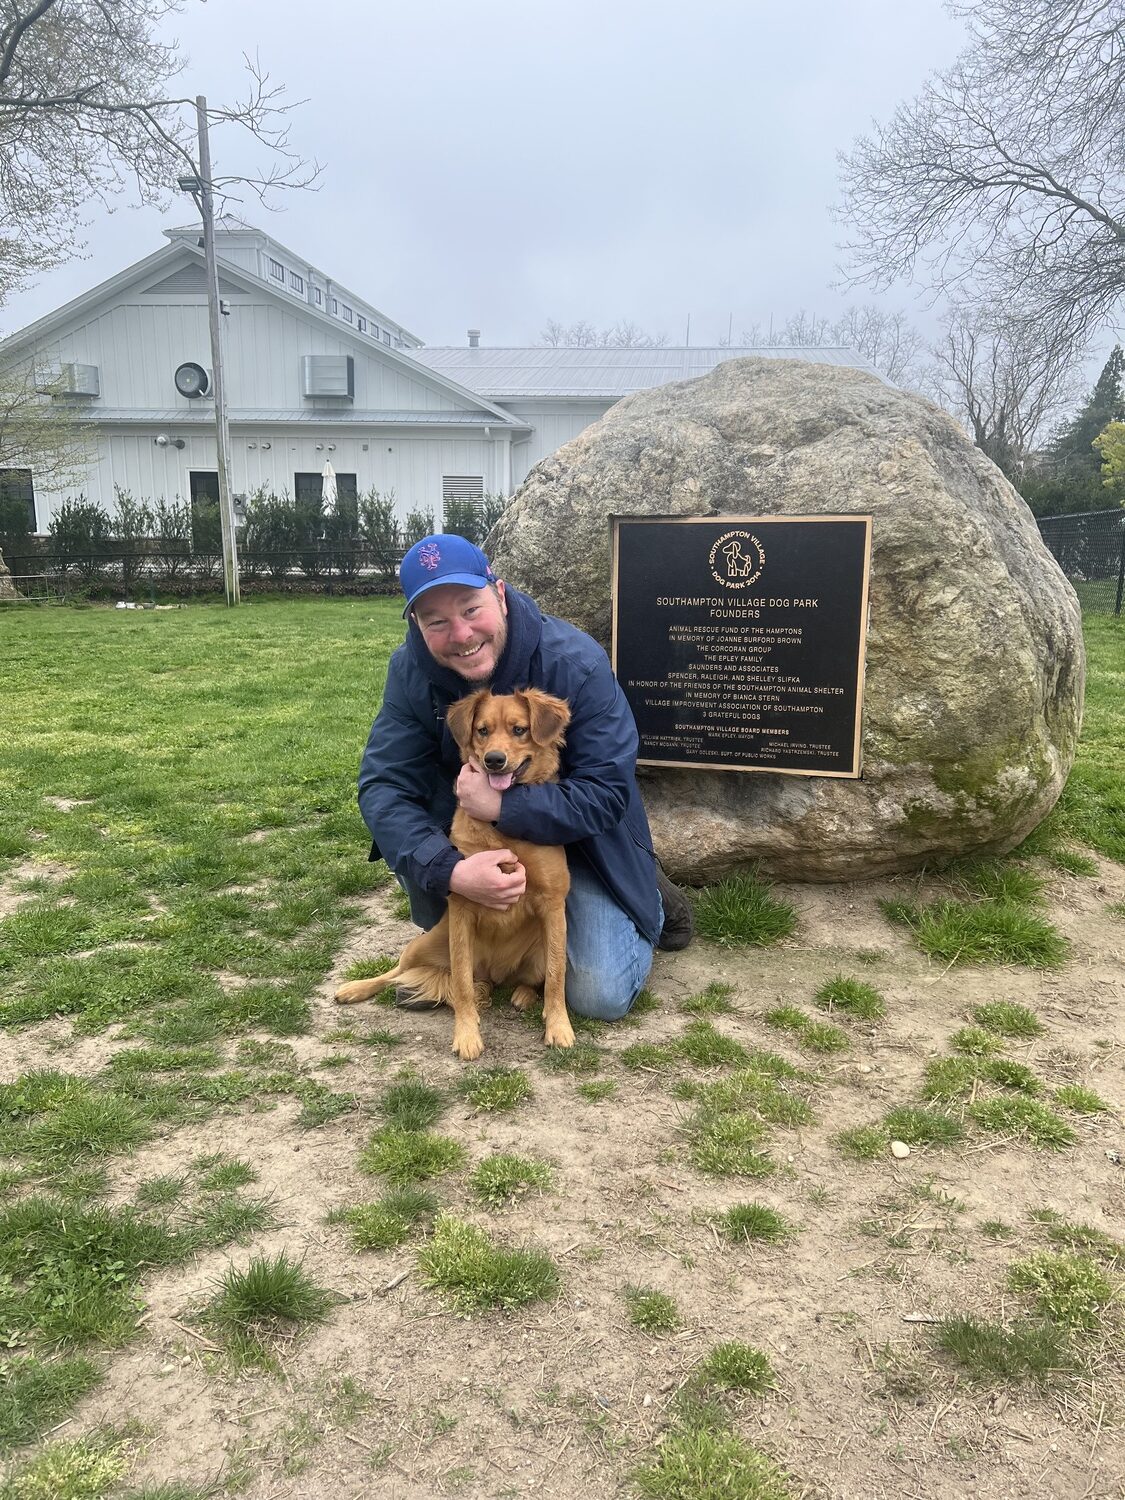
[{"xmin": 0, "ymin": 219, "xmax": 869, "ymax": 531}]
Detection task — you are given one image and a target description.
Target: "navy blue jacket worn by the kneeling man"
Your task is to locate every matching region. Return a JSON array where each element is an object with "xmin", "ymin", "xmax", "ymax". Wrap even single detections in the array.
[{"xmin": 360, "ymin": 587, "xmax": 660, "ymax": 944}]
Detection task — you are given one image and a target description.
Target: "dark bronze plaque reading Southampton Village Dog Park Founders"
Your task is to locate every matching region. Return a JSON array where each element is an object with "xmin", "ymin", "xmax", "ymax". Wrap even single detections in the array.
[{"xmin": 612, "ymin": 516, "xmax": 872, "ymax": 777}]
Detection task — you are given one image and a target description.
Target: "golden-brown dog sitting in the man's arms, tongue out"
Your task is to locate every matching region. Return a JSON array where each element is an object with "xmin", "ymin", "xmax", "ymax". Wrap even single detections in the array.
[{"xmin": 336, "ymin": 687, "xmax": 575, "ymax": 1062}]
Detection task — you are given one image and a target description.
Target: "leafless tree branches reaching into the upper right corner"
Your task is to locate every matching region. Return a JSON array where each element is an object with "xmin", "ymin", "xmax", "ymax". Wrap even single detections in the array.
[{"xmin": 840, "ymin": 0, "xmax": 1125, "ymax": 347}]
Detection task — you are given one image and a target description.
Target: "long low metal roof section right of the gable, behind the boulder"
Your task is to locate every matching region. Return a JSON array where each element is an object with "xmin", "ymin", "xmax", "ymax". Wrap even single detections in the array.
[{"xmin": 410, "ymin": 345, "xmax": 882, "ymax": 401}]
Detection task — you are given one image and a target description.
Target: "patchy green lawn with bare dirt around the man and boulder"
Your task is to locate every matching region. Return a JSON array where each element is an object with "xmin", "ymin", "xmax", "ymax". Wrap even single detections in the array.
[{"xmin": 0, "ymin": 599, "xmax": 1125, "ymax": 1500}]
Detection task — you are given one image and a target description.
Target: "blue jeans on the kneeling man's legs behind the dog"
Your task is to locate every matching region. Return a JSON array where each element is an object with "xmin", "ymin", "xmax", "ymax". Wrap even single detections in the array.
[{"xmin": 402, "ymin": 866, "xmax": 653, "ymax": 1022}]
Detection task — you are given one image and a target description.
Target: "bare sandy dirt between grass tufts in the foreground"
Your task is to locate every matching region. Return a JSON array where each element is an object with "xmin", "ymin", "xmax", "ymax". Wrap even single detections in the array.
[{"xmin": 0, "ymin": 861, "xmax": 1125, "ymax": 1500}]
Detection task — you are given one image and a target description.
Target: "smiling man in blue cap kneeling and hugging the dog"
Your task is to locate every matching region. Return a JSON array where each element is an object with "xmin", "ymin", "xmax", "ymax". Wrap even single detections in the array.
[{"xmin": 360, "ymin": 533, "xmax": 693, "ymax": 1022}]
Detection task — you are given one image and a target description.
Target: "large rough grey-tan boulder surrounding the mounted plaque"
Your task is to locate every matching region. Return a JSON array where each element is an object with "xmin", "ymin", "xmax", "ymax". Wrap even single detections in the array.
[{"xmin": 489, "ymin": 360, "xmax": 1085, "ymax": 882}]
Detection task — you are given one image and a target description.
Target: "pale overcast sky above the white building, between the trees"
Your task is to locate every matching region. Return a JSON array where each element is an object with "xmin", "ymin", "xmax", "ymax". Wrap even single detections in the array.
[{"xmin": 0, "ymin": 0, "xmax": 963, "ymax": 345}]
